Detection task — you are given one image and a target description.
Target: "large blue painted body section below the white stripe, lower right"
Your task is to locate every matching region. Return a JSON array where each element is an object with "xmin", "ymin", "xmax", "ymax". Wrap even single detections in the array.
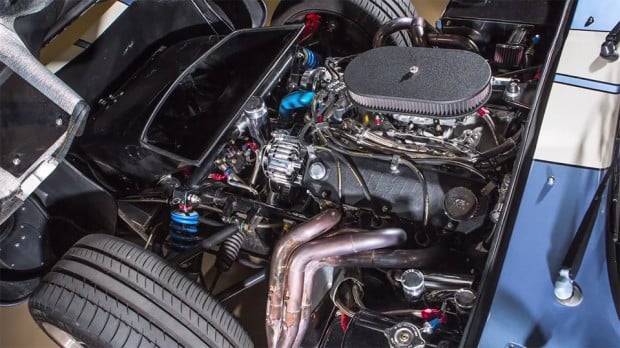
[{"xmin": 480, "ymin": 161, "xmax": 620, "ymax": 347}]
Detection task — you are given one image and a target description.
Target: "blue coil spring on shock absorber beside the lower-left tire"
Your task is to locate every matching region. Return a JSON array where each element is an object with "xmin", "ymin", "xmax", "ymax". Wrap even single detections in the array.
[{"xmin": 168, "ymin": 210, "xmax": 202, "ymax": 251}]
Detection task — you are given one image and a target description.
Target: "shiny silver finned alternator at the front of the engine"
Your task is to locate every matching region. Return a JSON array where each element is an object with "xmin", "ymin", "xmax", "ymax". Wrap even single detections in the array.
[{"xmin": 263, "ymin": 132, "xmax": 307, "ymax": 188}]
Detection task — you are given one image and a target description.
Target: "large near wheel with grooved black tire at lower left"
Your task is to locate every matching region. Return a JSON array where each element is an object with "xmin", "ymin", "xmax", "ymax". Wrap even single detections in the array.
[{"xmin": 29, "ymin": 234, "xmax": 253, "ymax": 347}]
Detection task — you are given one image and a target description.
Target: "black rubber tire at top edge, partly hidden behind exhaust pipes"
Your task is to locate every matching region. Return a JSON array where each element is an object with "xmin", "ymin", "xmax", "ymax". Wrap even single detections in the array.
[{"xmin": 271, "ymin": 0, "xmax": 417, "ymax": 46}]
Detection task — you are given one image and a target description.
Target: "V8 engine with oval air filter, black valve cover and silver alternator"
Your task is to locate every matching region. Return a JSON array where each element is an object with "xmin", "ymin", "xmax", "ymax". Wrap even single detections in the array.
[{"xmin": 266, "ymin": 47, "xmax": 498, "ymax": 233}]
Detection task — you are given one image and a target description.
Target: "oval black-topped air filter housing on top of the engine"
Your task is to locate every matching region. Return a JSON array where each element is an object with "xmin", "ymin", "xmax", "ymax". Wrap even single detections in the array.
[{"xmin": 344, "ymin": 46, "xmax": 491, "ymax": 118}]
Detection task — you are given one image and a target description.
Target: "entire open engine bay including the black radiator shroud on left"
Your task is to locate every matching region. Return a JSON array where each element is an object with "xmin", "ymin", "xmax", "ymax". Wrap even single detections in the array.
[{"xmin": 0, "ymin": 1, "xmax": 568, "ymax": 348}]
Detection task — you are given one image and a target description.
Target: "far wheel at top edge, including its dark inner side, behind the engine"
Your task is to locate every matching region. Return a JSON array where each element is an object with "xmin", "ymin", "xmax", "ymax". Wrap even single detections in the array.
[{"xmin": 271, "ymin": 0, "xmax": 416, "ymax": 56}]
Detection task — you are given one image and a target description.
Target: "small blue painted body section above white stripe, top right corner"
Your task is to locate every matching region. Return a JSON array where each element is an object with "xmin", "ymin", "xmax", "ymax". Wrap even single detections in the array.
[{"xmin": 571, "ymin": 0, "xmax": 620, "ymax": 31}]
